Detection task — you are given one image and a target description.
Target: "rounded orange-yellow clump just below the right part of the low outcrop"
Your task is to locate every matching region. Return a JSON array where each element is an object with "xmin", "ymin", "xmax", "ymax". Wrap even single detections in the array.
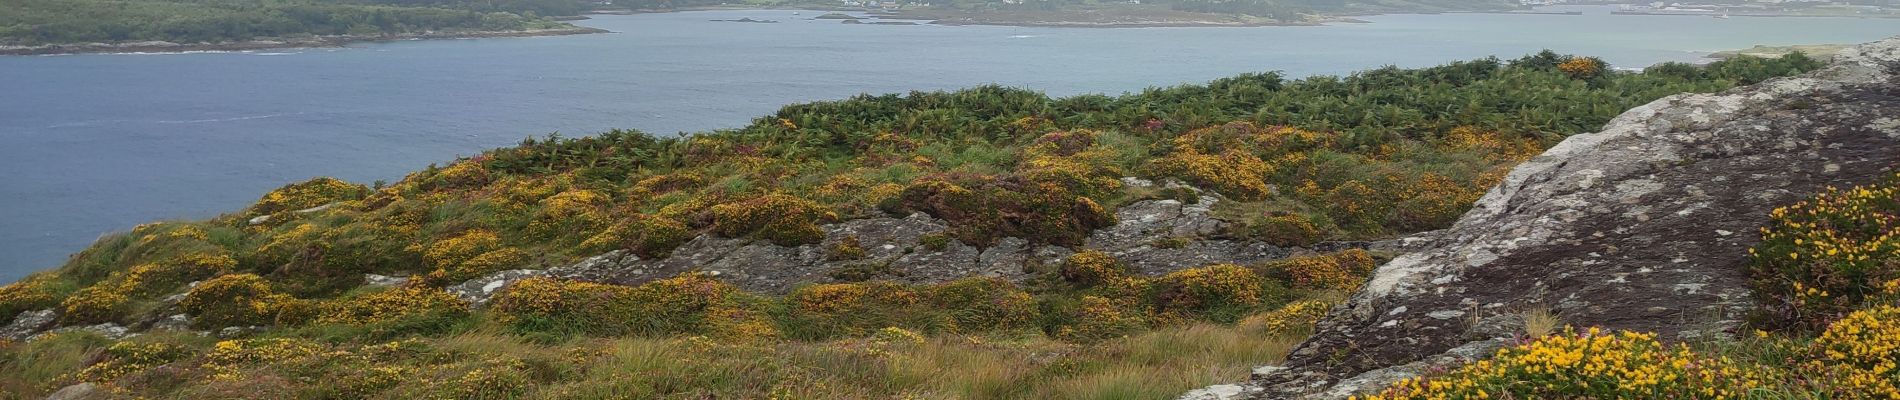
[{"xmin": 1151, "ymin": 264, "xmax": 1269, "ymax": 322}]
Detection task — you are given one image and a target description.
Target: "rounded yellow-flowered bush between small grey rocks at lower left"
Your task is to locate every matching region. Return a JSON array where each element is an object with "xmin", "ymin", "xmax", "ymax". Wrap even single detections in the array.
[{"xmin": 179, "ymin": 273, "xmax": 291, "ymax": 328}]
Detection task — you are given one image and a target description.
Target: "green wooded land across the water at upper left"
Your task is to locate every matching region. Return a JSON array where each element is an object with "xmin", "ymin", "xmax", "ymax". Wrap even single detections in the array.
[{"xmin": 0, "ymin": 0, "xmax": 606, "ymax": 55}]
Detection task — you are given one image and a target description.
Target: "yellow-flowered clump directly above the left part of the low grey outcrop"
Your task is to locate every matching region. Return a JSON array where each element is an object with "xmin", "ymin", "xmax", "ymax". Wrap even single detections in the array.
[{"xmin": 711, "ymin": 193, "xmax": 836, "ymax": 246}]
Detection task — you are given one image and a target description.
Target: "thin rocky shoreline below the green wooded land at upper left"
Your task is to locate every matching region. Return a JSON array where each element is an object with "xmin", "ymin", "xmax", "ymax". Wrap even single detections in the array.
[{"xmin": 0, "ymin": 27, "xmax": 610, "ymax": 55}]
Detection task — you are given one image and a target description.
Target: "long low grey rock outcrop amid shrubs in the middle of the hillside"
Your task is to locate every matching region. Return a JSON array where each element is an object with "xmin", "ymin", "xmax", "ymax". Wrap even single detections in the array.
[{"xmin": 549, "ymin": 182, "xmax": 1288, "ymax": 294}]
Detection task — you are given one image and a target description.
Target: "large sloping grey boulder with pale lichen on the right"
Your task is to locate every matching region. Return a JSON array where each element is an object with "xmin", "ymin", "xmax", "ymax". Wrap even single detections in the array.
[{"xmin": 1243, "ymin": 38, "xmax": 1900, "ymax": 398}]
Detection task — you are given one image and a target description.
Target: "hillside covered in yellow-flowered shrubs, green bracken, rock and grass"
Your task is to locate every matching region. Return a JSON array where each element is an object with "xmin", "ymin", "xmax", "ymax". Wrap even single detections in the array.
[{"xmin": 0, "ymin": 51, "xmax": 1818, "ymax": 398}]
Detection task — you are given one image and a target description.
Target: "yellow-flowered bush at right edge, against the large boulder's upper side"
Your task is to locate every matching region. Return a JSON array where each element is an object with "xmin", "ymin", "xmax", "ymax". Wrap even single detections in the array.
[{"xmin": 1748, "ymin": 174, "xmax": 1900, "ymax": 330}]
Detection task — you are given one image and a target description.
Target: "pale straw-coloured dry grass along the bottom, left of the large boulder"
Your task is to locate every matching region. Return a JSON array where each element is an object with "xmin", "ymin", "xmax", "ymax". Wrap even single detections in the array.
[{"xmin": 534, "ymin": 324, "xmax": 1300, "ymax": 398}]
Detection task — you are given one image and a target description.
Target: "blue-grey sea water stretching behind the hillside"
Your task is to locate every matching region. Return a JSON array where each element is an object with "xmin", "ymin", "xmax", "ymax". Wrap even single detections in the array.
[{"xmin": 0, "ymin": 8, "xmax": 1900, "ymax": 282}]
